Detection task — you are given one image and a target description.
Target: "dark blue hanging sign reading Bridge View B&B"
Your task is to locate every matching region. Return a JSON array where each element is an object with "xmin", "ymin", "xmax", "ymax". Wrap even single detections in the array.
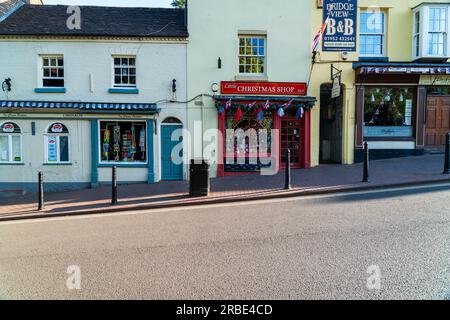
[{"xmin": 322, "ymin": 0, "xmax": 358, "ymax": 52}]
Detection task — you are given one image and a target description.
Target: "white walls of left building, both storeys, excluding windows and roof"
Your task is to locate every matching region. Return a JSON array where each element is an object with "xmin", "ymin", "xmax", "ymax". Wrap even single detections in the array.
[{"xmin": 0, "ymin": 39, "xmax": 187, "ymax": 188}]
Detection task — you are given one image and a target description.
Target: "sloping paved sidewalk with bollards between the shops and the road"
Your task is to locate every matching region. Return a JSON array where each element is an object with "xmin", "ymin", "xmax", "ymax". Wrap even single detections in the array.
[{"xmin": 0, "ymin": 155, "xmax": 450, "ymax": 220}]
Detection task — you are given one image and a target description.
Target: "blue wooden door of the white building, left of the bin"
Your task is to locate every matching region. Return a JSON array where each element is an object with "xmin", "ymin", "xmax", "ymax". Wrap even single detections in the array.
[{"xmin": 161, "ymin": 125, "xmax": 183, "ymax": 180}]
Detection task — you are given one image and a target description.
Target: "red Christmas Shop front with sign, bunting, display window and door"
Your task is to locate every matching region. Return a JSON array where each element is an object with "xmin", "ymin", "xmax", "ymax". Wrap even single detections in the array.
[{"xmin": 215, "ymin": 82, "xmax": 316, "ymax": 176}]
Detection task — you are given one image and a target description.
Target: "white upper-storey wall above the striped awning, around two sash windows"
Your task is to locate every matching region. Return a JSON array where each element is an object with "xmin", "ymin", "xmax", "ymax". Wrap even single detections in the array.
[{"xmin": 0, "ymin": 39, "xmax": 187, "ymax": 103}]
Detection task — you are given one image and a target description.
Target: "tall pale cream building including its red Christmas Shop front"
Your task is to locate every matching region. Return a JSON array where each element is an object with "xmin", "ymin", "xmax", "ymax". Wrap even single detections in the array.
[{"xmin": 187, "ymin": 0, "xmax": 317, "ymax": 176}]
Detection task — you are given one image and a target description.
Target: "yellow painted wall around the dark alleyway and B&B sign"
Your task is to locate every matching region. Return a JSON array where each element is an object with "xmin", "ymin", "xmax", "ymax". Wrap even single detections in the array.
[{"xmin": 309, "ymin": 0, "xmax": 449, "ymax": 166}]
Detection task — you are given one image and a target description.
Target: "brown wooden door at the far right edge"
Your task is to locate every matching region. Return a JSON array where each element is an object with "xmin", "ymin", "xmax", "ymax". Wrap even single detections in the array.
[{"xmin": 425, "ymin": 96, "xmax": 450, "ymax": 149}]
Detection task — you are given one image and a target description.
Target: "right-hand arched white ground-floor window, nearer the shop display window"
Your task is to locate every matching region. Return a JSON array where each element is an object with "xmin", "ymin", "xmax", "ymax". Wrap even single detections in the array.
[{"xmin": 45, "ymin": 123, "xmax": 70, "ymax": 163}]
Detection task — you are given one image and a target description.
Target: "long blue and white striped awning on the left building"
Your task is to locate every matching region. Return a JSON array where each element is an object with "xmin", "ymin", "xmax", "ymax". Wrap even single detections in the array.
[{"xmin": 0, "ymin": 101, "xmax": 159, "ymax": 113}]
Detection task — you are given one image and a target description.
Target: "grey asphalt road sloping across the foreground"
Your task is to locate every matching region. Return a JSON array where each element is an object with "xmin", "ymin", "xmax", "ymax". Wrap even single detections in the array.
[{"xmin": 0, "ymin": 186, "xmax": 450, "ymax": 299}]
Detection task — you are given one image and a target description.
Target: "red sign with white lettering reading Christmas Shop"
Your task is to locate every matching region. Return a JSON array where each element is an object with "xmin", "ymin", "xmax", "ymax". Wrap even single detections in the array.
[{"xmin": 221, "ymin": 81, "xmax": 306, "ymax": 96}]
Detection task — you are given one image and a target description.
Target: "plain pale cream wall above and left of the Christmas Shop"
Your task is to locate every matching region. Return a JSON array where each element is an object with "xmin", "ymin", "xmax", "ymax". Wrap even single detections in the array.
[{"xmin": 188, "ymin": 0, "xmax": 311, "ymax": 176}]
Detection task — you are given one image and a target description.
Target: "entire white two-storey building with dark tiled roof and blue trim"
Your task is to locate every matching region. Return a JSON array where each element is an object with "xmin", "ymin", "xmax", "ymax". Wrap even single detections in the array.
[{"xmin": 0, "ymin": 5, "xmax": 188, "ymax": 191}]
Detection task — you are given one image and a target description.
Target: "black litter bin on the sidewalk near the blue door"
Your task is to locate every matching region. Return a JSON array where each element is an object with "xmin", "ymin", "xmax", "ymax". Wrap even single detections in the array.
[{"xmin": 189, "ymin": 159, "xmax": 210, "ymax": 197}]
